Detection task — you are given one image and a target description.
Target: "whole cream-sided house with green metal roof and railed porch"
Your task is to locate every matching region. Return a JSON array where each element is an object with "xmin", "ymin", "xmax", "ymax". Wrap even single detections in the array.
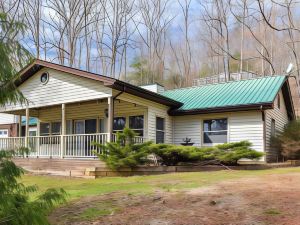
[{"xmin": 0, "ymin": 60, "xmax": 295, "ymax": 162}]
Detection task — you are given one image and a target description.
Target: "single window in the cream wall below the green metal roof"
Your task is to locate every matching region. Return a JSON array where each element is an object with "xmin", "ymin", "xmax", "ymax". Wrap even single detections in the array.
[{"xmin": 203, "ymin": 119, "xmax": 227, "ymax": 144}]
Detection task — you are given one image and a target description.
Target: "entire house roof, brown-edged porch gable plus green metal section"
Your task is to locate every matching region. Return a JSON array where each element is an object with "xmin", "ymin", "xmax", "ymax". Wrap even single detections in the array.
[{"xmin": 16, "ymin": 59, "xmax": 295, "ymax": 119}]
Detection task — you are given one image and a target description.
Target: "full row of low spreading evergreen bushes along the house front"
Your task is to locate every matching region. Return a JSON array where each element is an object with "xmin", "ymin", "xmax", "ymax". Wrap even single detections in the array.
[{"xmin": 94, "ymin": 128, "xmax": 263, "ymax": 170}]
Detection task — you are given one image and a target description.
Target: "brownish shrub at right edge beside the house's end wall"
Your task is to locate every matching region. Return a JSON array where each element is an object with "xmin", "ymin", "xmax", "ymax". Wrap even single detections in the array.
[{"xmin": 271, "ymin": 120, "xmax": 300, "ymax": 159}]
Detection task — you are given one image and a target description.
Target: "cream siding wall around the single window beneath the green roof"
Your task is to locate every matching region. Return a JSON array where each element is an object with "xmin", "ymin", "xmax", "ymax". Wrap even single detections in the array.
[{"xmin": 174, "ymin": 111, "xmax": 264, "ymax": 152}]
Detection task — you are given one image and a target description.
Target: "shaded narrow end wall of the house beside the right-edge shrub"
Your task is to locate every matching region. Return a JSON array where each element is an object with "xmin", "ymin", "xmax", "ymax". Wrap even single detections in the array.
[{"xmin": 265, "ymin": 91, "xmax": 289, "ymax": 162}]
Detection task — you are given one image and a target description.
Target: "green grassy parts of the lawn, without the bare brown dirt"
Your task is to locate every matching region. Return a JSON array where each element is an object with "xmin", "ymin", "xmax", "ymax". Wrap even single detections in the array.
[{"xmin": 22, "ymin": 167, "xmax": 300, "ymax": 222}]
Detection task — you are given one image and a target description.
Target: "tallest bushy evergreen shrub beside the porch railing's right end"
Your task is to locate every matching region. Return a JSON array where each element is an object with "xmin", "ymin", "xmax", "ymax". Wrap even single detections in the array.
[{"xmin": 93, "ymin": 128, "xmax": 151, "ymax": 170}]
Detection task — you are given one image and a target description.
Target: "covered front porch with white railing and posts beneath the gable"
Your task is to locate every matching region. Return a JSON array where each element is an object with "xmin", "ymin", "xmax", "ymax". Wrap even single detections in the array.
[{"xmin": 0, "ymin": 97, "xmax": 148, "ymax": 158}]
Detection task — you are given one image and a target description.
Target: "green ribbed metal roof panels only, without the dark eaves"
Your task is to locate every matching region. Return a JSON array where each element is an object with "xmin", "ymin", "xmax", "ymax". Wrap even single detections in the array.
[{"xmin": 162, "ymin": 76, "xmax": 286, "ymax": 111}]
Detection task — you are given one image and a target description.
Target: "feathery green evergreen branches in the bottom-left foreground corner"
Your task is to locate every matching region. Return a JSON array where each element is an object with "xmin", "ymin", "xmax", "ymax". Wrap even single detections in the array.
[{"xmin": 0, "ymin": 151, "xmax": 65, "ymax": 225}]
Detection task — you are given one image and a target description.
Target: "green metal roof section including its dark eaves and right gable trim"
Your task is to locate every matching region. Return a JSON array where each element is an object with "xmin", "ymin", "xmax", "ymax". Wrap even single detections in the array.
[{"xmin": 163, "ymin": 76, "xmax": 294, "ymax": 117}]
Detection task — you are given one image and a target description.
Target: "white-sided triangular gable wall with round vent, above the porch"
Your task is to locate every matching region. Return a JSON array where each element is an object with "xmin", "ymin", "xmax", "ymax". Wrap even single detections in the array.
[{"xmin": 0, "ymin": 69, "xmax": 112, "ymax": 112}]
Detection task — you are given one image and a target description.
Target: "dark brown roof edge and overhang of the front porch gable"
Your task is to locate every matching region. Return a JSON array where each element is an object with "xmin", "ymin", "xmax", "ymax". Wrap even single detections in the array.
[{"xmin": 16, "ymin": 59, "xmax": 183, "ymax": 108}]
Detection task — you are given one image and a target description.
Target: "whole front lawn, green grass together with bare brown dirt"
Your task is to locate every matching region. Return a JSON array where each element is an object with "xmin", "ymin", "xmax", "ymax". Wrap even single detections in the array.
[{"xmin": 23, "ymin": 168, "xmax": 300, "ymax": 225}]
